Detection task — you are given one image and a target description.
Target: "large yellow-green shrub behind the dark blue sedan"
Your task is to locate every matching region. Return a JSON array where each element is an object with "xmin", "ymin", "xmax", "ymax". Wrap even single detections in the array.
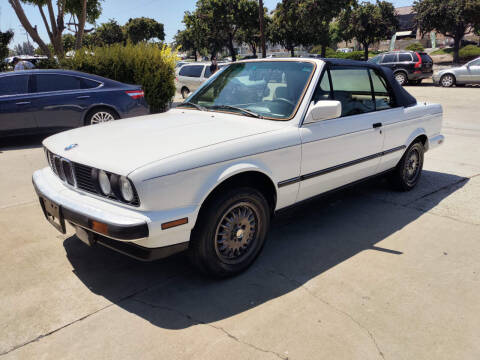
[{"xmin": 66, "ymin": 42, "xmax": 177, "ymax": 113}]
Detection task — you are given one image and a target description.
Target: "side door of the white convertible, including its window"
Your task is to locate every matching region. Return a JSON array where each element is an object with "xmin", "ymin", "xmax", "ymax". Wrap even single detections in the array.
[{"xmin": 297, "ymin": 66, "xmax": 383, "ymax": 201}]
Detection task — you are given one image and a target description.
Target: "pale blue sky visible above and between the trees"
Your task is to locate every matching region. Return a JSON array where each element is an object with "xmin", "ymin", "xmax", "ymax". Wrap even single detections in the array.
[{"xmin": 0, "ymin": 0, "xmax": 413, "ymax": 47}]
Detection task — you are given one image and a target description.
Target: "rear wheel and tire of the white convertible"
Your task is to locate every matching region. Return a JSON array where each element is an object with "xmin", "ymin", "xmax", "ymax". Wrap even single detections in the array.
[{"xmin": 389, "ymin": 141, "xmax": 425, "ymax": 191}]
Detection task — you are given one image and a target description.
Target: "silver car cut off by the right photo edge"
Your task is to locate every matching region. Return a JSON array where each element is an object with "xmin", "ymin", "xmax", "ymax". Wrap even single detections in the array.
[{"xmin": 433, "ymin": 57, "xmax": 480, "ymax": 87}]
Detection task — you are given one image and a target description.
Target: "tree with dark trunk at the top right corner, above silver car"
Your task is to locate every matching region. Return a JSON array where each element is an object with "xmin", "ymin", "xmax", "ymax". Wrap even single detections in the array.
[{"xmin": 413, "ymin": 0, "xmax": 480, "ymax": 63}]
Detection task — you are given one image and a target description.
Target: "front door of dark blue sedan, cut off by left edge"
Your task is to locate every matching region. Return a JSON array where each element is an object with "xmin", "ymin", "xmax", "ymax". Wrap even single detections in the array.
[{"xmin": 0, "ymin": 73, "xmax": 37, "ymax": 134}]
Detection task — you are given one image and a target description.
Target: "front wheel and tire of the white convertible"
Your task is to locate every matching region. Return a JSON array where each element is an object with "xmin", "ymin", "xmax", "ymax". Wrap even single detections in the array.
[{"xmin": 189, "ymin": 187, "xmax": 270, "ymax": 278}]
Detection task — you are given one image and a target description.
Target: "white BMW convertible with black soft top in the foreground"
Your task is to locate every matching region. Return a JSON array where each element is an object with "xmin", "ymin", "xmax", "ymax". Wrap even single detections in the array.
[{"xmin": 33, "ymin": 58, "xmax": 444, "ymax": 277}]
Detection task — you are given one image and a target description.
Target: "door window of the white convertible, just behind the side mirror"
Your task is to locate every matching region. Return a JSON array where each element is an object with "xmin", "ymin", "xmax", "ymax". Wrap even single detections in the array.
[{"xmin": 330, "ymin": 67, "xmax": 375, "ymax": 116}]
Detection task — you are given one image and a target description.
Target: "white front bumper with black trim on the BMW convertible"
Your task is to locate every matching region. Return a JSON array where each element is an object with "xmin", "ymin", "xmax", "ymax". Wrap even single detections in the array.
[{"xmin": 32, "ymin": 168, "xmax": 190, "ymax": 261}]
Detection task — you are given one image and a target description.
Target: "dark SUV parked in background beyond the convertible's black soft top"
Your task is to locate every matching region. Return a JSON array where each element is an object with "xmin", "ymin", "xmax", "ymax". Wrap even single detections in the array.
[{"xmin": 369, "ymin": 51, "xmax": 433, "ymax": 86}]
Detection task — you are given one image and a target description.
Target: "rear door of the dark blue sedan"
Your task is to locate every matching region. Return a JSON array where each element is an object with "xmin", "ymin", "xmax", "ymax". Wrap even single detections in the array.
[{"xmin": 32, "ymin": 73, "xmax": 89, "ymax": 130}]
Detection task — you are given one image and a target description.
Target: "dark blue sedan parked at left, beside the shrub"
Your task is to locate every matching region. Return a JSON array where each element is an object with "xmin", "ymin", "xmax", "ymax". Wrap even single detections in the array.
[{"xmin": 0, "ymin": 70, "xmax": 149, "ymax": 137}]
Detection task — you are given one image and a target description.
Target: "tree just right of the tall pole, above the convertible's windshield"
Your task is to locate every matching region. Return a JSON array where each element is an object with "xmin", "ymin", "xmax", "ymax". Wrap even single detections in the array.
[{"xmin": 271, "ymin": 0, "xmax": 311, "ymax": 57}]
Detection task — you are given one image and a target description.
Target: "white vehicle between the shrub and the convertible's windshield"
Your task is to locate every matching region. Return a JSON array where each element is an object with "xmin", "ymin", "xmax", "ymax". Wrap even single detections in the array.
[{"xmin": 175, "ymin": 62, "xmax": 226, "ymax": 99}]
